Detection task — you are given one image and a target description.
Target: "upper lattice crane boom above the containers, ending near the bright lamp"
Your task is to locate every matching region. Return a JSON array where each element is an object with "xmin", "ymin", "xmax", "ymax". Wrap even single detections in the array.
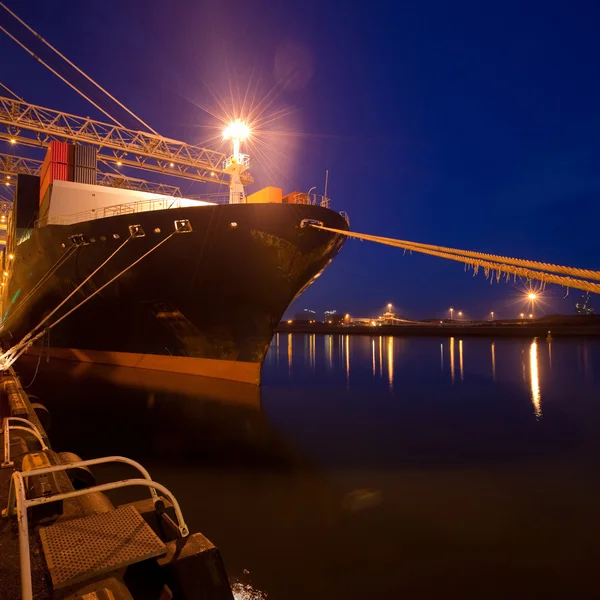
[{"xmin": 0, "ymin": 97, "xmax": 251, "ymax": 185}]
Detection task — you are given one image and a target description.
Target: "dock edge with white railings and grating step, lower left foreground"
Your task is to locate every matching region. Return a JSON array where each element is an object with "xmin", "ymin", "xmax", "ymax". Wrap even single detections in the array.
[{"xmin": 0, "ymin": 371, "xmax": 233, "ymax": 600}]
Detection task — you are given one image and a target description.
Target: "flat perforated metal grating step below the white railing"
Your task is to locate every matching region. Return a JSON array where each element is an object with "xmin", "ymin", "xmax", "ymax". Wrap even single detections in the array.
[{"xmin": 40, "ymin": 506, "xmax": 166, "ymax": 589}]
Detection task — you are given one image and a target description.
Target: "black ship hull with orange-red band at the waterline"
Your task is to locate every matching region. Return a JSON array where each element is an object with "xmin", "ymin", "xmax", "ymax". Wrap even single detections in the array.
[{"xmin": 0, "ymin": 204, "xmax": 347, "ymax": 384}]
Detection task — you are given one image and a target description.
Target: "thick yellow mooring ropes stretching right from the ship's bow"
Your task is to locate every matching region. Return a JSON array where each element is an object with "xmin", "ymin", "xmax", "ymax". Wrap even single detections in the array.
[{"xmin": 310, "ymin": 224, "xmax": 600, "ymax": 294}]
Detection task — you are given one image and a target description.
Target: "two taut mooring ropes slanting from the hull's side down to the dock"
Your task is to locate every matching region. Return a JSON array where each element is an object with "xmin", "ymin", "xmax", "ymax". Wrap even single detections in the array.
[{"xmin": 0, "ymin": 230, "xmax": 177, "ymax": 370}]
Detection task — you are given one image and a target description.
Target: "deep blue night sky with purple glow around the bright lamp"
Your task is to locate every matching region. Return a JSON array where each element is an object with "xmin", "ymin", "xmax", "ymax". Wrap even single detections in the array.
[{"xmin": 0, "ymin": 0, "xmax": 600, "ymax": 317}]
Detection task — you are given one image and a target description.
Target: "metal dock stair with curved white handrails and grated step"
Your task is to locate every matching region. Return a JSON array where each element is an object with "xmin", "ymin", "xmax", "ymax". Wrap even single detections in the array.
[{"xmin": 2, "ymin": 454, "xmax": 189, "ymax": 600}]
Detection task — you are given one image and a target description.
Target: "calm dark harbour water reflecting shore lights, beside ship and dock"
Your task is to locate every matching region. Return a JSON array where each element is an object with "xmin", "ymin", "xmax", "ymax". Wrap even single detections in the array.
[{"xmin": 19, "ymin": 334, "xmax": 600, "ymax": 600}]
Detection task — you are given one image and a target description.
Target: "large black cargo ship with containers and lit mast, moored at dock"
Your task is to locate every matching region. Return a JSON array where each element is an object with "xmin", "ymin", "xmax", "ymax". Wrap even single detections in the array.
[{"xmin": 0, "ymin": 142, "xmax": 348, "ymax": 384}]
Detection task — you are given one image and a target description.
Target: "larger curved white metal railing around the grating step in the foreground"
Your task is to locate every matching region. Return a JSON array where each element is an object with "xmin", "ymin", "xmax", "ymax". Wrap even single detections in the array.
[{"xmin": 2, "ymin": 456, "xmax": 189, "ymax": 600}]
